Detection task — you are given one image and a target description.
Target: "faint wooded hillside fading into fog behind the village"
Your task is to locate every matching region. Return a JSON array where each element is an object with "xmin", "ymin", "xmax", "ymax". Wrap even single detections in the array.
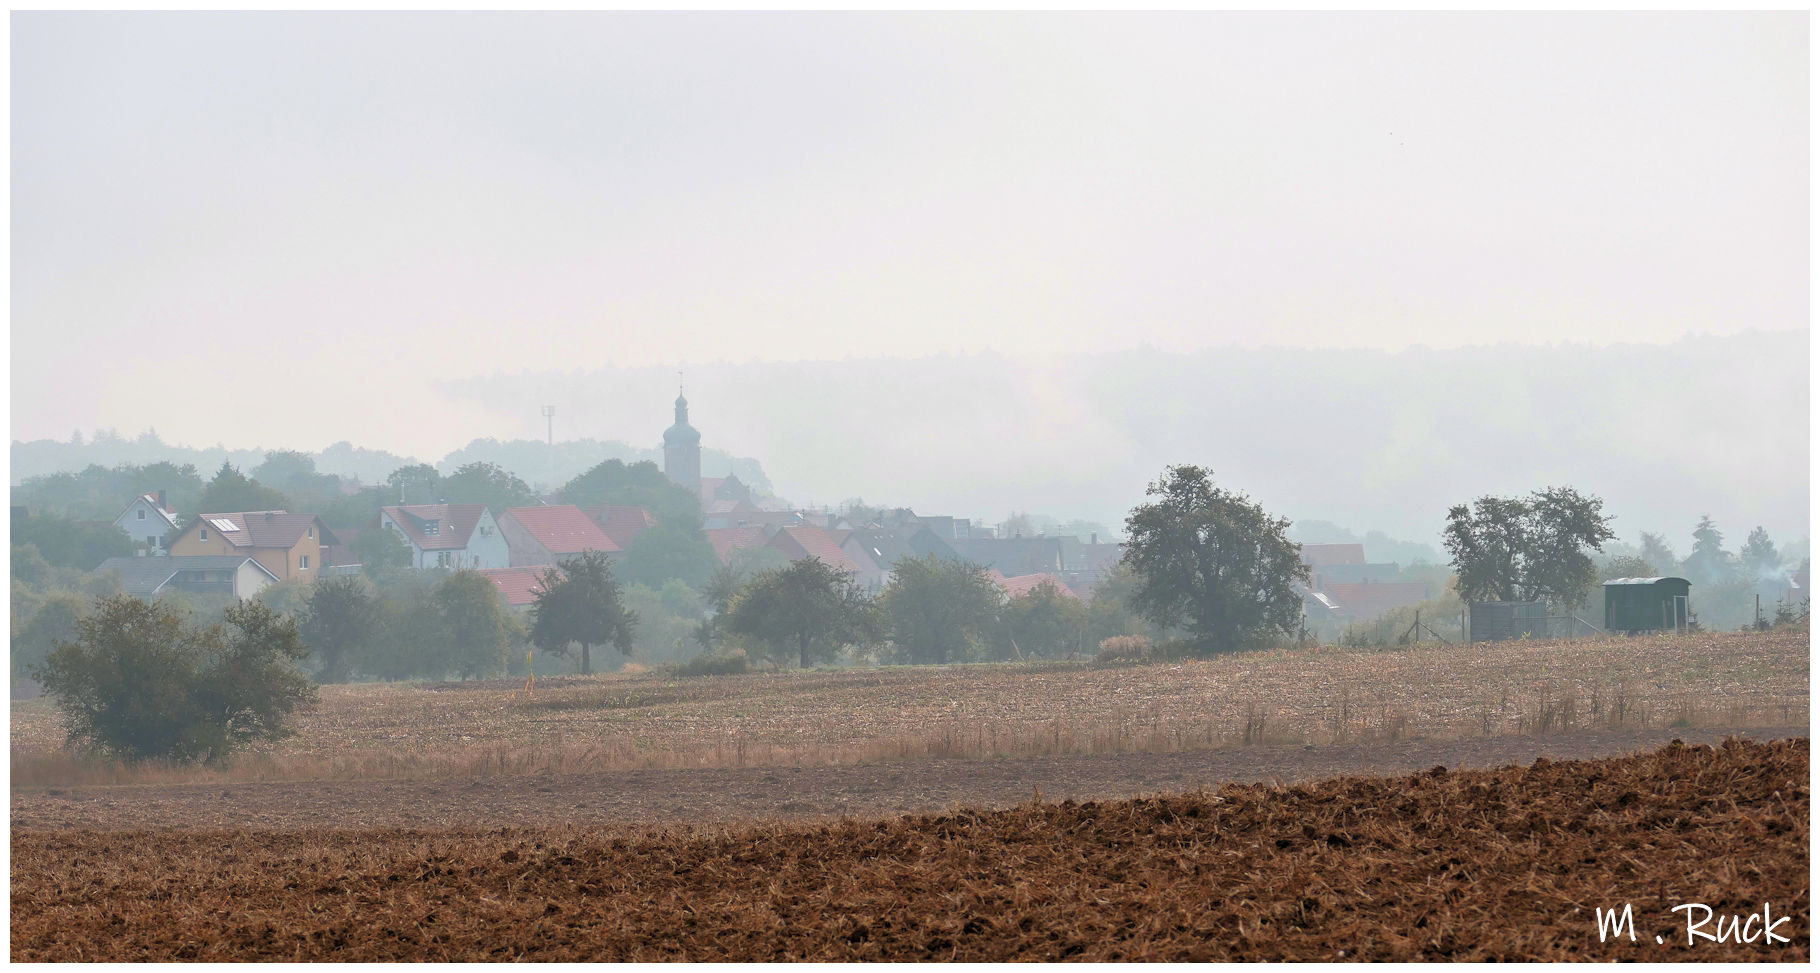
[{"xmin": 429, "ymin": 331, "xmax": 1809, "ymax": 549}]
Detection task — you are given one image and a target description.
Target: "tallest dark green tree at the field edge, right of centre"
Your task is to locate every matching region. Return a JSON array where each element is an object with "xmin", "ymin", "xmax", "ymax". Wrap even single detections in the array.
[{"xmin": 1123, "ymin": 466, "xmax": 1309, "ymax": 653}]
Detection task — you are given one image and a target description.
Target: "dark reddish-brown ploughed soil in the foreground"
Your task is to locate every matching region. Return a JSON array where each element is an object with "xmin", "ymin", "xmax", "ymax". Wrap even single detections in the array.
[{"xmin": 11, "ymin": 740, "xmax": 1809, "ymax": 960}]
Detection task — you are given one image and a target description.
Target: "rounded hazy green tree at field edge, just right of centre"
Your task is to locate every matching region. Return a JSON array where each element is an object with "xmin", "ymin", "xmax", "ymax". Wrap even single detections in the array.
[{"xmin": 879, "ymin": 555, "xmax": 1005, "ymax": 666}]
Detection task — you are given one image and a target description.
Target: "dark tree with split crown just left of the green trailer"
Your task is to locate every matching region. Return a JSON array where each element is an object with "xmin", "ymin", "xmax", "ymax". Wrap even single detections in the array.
[{"xmin": 1443, "ymin": 487, "xmax": 1618, "ymax": 611}]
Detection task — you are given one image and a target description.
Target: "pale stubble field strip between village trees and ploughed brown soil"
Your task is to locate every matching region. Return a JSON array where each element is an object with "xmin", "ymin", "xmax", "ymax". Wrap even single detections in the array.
[{"xmin": 11, "ymin": 633, "xmax": 1809, "ymax": 787}]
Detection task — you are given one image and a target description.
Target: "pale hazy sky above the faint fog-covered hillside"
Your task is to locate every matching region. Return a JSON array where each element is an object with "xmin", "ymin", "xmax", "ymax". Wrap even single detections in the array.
[{"xmin": 11, "ymin": 13, "xmax": 1809, "ymax": 460}]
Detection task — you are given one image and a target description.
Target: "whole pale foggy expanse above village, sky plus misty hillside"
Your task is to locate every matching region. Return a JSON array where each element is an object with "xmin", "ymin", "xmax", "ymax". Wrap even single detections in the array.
[{"xmin": 11, "ymin": 13, "xmax": 1809, "ymax": 542}]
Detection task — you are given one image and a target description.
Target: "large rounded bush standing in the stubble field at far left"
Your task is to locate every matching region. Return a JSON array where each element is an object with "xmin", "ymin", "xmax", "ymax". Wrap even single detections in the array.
[{"xmin": 38, "ymin": 597, "xmax": 317, "ymax": 762}]
